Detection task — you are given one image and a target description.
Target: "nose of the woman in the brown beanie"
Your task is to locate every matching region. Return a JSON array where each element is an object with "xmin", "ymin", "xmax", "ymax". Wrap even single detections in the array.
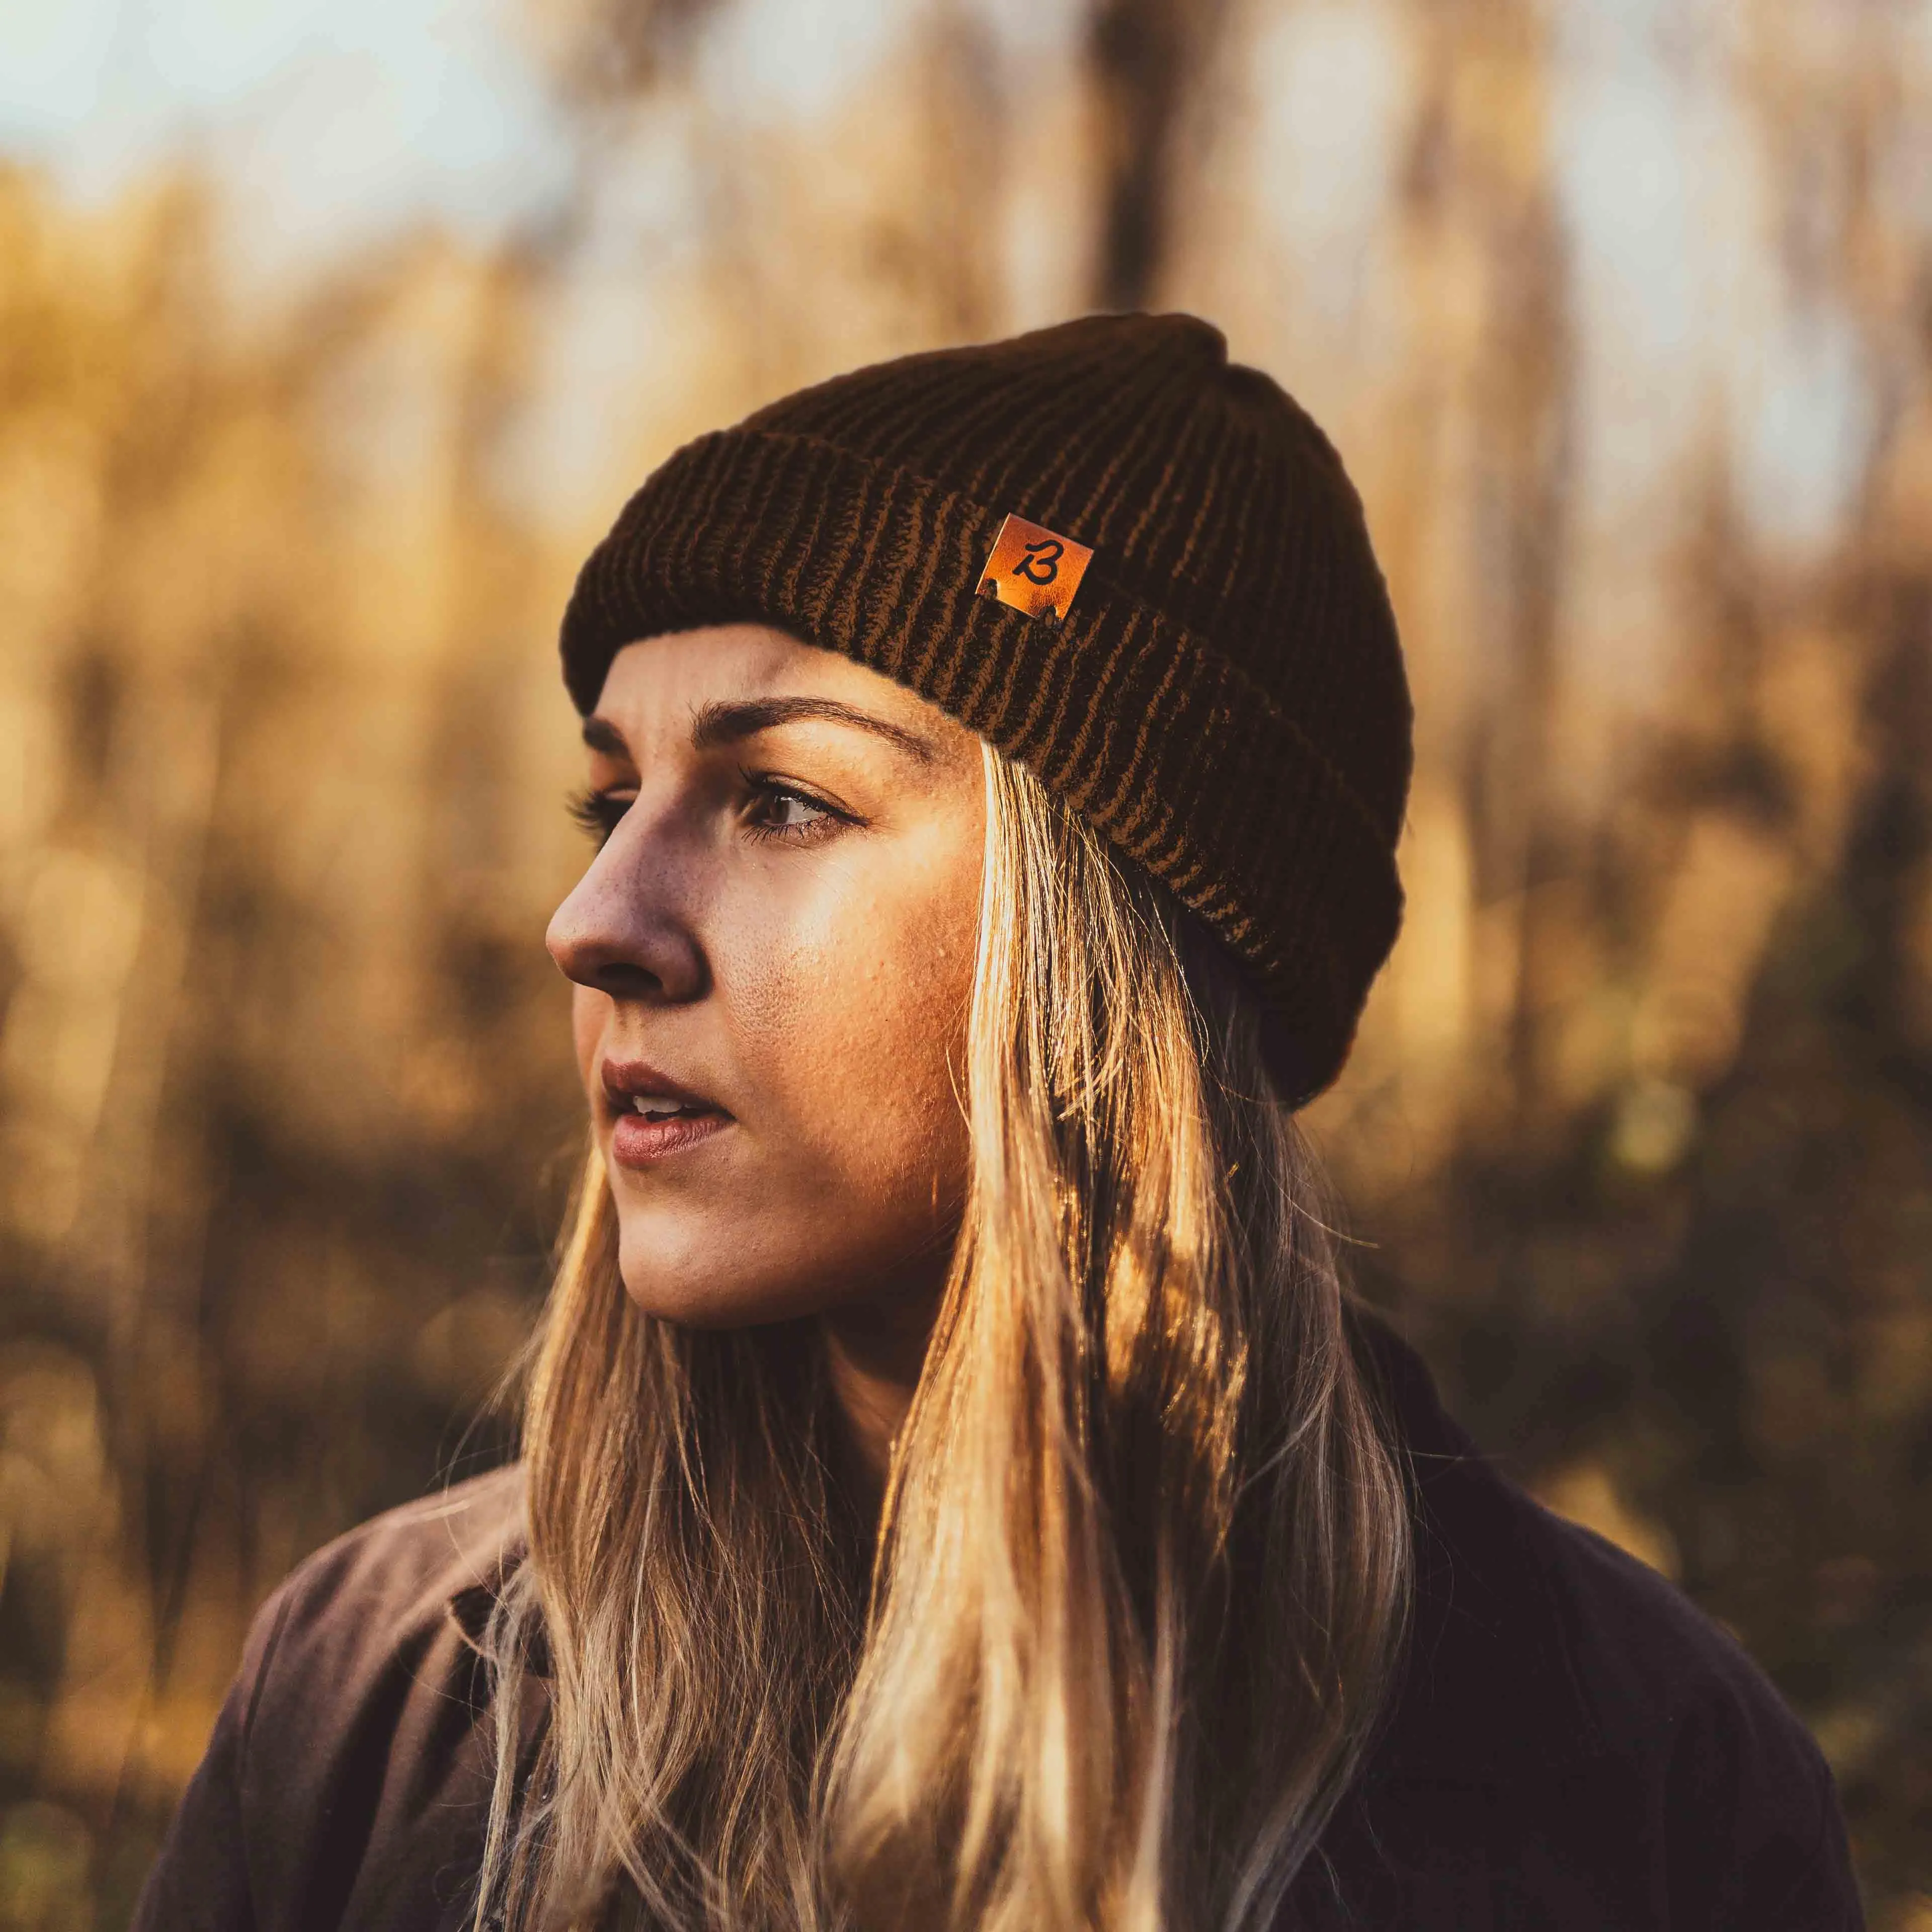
[{"xmin": 545, "ymin": 806, "xmax": 707, "ymax": 1005}]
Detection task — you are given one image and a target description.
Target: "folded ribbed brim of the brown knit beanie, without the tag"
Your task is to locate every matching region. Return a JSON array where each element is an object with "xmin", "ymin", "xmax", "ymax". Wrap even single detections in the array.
[{"xmin": 562, "ymin": 427, "xmax": 1403, "ymax": 1103}]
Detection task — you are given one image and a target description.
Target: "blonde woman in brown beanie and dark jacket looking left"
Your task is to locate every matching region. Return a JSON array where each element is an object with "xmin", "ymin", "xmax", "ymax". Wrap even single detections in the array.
[{"xmin": 141, "ymin": 317, "xmax": 1859, "ymax": 1932}]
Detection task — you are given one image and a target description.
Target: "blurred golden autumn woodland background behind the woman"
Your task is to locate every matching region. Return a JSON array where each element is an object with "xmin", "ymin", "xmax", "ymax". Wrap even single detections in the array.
[{"xmin": 0, "ymin": 0, "xmax": 1932, "ymax": 1932}]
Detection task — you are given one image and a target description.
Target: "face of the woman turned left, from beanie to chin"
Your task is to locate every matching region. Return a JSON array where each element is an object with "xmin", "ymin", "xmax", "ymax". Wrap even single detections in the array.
[{"xmin": 549, "ymin": 624, "xmax": 985, "ymax": 1327}]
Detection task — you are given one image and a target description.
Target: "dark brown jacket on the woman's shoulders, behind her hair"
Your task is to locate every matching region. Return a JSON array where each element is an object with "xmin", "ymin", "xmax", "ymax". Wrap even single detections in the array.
[{"xmin": 135, "ymin": 1325, "xmax": 1863, "ymax": 1932}]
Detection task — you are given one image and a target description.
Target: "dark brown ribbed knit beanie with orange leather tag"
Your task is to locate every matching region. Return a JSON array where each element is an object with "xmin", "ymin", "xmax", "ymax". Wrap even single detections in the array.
[{"xmin": 562, "ymin": 315, "xmax": 1410, "ymax": 1101}]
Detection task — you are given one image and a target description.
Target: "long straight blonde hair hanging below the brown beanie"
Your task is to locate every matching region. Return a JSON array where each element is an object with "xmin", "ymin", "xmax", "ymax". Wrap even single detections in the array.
[{"xmin": 477, "ymin": 750, "xmax": 1410, "ymax": 1932}]
